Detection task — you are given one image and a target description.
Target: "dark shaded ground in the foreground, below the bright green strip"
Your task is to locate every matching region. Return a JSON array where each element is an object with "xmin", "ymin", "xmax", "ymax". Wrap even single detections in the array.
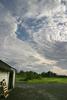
[{"xmin": 0, "ymin": 83, "xmax": 67, "ymax": 100}]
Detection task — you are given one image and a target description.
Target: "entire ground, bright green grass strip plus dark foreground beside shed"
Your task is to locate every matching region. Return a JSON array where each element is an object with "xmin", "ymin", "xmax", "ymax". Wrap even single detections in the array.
[{"xmin": 0, "ymin": 78, "xmax": 67, "ymax": 100}]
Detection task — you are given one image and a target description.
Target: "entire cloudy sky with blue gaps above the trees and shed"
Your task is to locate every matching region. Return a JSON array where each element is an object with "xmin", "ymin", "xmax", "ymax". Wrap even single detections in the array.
[{"xmin": 0, "ymin": 0, "xmax": 67, "ymax": 75}]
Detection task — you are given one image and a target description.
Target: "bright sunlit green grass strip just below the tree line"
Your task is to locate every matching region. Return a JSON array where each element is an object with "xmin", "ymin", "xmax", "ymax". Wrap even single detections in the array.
[{"xmin": 16, "ymin": 77, "xmax": 67, "ymax": 84}]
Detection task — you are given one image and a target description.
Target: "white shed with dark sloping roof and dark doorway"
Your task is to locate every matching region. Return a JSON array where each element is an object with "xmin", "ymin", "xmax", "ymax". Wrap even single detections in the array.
[{"xmin": 0, "ymin": 60, "xmax": 15, "ymax": 90}]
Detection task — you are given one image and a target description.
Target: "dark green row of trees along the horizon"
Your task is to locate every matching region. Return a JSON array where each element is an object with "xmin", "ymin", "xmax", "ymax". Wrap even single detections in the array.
[{"xmin": 17, "ymin": 71, "xmax": 67, "ymax": 81}]
